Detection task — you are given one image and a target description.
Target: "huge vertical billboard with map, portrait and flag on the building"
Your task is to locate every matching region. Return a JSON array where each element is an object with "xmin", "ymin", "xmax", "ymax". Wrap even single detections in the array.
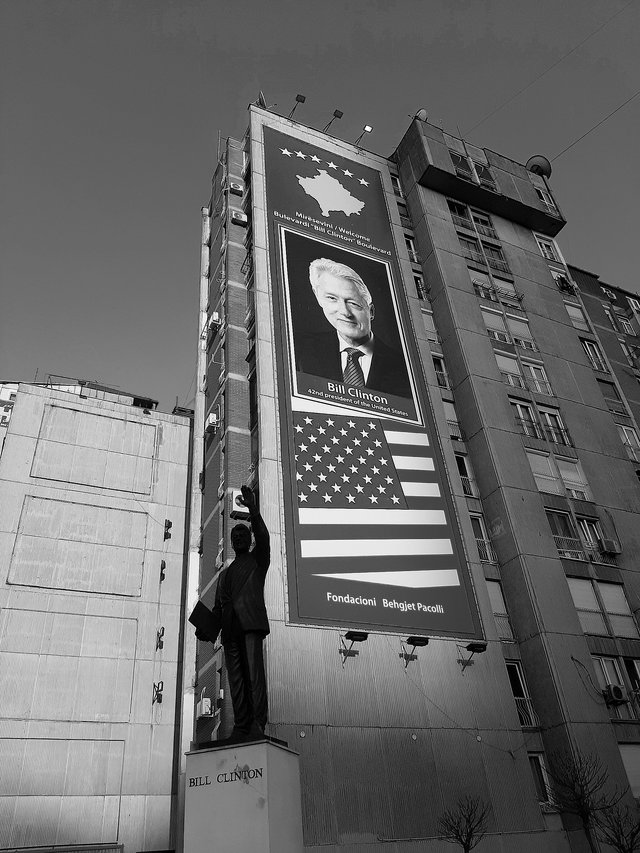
[{"xmin": 261, "ymin": 120, "xmax": 482, "ymax": 637}]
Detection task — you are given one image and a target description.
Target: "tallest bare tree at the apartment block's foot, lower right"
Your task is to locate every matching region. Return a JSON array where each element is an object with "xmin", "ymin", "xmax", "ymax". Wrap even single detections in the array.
[{"xmin": 549, "ymin": 750, "xmax": 626, "ymax": 853}]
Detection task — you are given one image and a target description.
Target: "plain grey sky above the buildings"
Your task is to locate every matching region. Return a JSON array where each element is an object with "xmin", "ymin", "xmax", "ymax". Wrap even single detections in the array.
[{"xmin": 0, "ymin": 0, "xmax": 640, "ymax": 411}]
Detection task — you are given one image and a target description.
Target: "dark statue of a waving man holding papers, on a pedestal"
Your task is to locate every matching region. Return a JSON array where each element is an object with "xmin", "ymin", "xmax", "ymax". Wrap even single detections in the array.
[{"xmin": 194, "ymin": 486, "xmax": 270, "ymax": 741}]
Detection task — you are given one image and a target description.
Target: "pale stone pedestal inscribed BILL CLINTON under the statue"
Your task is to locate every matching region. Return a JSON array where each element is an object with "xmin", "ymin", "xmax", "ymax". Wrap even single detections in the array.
[{"xmin": 184, "ymin": 740, "xmax": 303, "ymax": 853}]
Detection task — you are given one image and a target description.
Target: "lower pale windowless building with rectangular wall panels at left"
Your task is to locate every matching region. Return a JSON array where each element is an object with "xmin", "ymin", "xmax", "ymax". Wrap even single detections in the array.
[{"xmin": 0, "ymin": 377, "xmax": 192, "ymax": 853}]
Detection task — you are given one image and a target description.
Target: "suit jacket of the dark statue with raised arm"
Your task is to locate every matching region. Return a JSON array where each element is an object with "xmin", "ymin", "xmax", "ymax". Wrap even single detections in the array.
[{"xmin": 213, "ymin": 513, "xmax": 271, "ymax": 644}]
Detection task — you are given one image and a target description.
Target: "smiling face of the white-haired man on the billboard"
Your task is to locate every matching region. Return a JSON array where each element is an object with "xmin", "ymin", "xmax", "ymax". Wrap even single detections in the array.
[{"xmin": 316, "ymin": 272, "xmax": 373, "ymax": 346}]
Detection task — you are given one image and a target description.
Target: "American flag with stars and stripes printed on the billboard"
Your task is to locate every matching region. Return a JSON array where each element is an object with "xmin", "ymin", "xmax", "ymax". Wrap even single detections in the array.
[{"xmin": 294, "ymin": 412, "xmax": 460, "ymax": 589}]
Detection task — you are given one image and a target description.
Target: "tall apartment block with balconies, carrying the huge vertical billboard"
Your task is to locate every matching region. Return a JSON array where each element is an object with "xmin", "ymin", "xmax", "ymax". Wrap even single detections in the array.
[{"xmin": 194, "ymin": 107, "xmax": 640, "ymax": 853}]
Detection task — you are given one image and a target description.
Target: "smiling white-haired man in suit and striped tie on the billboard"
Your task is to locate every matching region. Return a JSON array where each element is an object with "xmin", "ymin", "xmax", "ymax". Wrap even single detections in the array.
[{"xmin": 295, "ymin": 257, "xmax": 411, "ymax": 397}]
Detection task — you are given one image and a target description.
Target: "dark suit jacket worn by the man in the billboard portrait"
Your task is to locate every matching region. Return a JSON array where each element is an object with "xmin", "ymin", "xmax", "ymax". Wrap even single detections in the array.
[{"xmin": 296, "ymin": 334, "xmax": 411, "ymax": 397}]
